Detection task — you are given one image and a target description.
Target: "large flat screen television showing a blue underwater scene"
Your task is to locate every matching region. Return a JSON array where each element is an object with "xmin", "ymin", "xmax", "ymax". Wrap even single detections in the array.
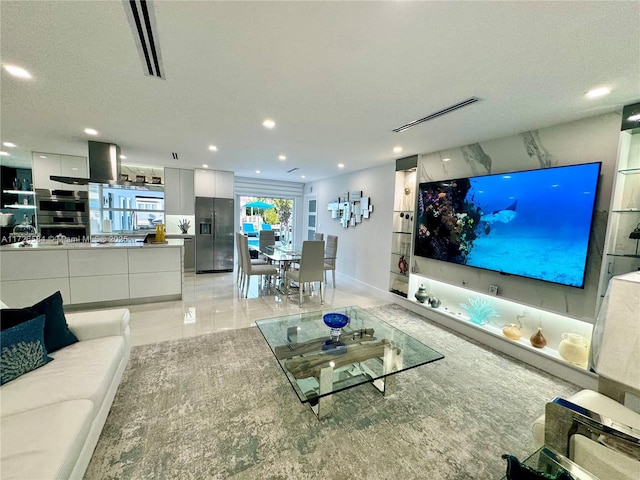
[{"xmin": 414, "ymin": 163, "xmax": 601, "ymax": 288}]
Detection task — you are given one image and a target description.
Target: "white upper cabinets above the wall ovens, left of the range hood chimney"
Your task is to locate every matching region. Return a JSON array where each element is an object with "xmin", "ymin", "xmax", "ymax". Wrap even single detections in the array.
[{"xmin": 32, "ymin": 152, "xmax": 89, "ymax": 191}]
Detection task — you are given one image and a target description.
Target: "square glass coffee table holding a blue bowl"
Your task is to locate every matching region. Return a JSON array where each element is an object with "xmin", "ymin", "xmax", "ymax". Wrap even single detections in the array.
[{"xmin": 256, "ymin": 306, "xmax": 444, "ymax": 419}]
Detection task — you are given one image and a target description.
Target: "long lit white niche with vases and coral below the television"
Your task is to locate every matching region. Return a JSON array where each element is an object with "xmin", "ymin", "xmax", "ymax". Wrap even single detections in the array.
[{"xmin": 408, "ymin": 274, "xmax": 593, "ymax": 370}]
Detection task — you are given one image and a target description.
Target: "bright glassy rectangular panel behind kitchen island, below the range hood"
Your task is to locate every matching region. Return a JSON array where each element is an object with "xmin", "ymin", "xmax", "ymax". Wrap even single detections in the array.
[{"xmin": 89, "ymin": 183, "xmax": 165, "ymax": 235}]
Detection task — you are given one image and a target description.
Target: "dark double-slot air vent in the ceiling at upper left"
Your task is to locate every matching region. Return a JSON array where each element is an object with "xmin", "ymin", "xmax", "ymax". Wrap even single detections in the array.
[{"xmin": 122, "ymin": 0, "xmax": 164, "ymax": 78}]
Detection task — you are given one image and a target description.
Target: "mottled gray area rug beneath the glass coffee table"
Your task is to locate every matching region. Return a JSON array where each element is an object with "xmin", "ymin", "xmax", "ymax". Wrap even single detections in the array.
[{"xmin": 85, "ymin": 305, "xmax": 579, "ymax": 480}]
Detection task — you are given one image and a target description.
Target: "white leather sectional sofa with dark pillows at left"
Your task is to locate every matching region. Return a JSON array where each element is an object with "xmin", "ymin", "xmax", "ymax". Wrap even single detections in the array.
[{"xmin": 0, "ymin": 302, "xmax": 131, "ymax": 480}]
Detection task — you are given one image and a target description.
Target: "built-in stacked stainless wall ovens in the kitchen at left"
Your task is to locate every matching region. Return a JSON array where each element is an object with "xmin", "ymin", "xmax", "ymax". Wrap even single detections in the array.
[{"xmin": 36, "ymin": 188, "xmax": 89, "ymax": 239}]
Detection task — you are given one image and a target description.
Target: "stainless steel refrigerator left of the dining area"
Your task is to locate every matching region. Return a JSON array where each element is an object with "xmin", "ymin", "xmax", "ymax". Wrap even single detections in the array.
[{"xmin": 195, "ymin": 197, "xmax": 234, "ymax": 273}]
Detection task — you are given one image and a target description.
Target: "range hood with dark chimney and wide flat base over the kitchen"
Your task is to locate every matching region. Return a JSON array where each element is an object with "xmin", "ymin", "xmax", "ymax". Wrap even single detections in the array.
[{"xmin": 49, "ymin": 140, "xmax": 158, "ymax": 187}]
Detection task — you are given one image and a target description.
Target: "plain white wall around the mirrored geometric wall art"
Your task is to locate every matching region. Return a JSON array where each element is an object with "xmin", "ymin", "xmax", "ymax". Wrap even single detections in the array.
[{"xmin": 301, "ymin": 160, "xmax": 395, "ymax": 292}]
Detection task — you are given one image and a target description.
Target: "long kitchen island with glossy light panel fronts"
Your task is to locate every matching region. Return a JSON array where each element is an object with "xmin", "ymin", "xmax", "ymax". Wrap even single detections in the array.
[{"xmin": 0, "ymin": 239, "xmax": 184, "ymax": 309}]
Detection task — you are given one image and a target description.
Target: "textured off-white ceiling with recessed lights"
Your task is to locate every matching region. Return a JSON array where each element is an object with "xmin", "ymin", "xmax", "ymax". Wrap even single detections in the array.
[{"xmin": 0, "ymin": 0, "xmax": 640, "ymax": 182}]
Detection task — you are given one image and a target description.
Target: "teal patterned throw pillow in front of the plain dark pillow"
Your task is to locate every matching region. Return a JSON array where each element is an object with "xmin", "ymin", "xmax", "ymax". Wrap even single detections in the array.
[{"xmin": 0, "ymin": 315, "xmax": 53, "ymax": 385}]
